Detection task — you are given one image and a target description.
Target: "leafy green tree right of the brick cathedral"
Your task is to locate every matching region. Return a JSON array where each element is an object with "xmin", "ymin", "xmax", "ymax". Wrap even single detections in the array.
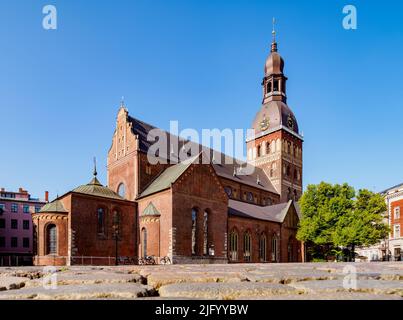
[{"xmin": 297, "ymin": 182, "xmax": 388, "ymax": 258}]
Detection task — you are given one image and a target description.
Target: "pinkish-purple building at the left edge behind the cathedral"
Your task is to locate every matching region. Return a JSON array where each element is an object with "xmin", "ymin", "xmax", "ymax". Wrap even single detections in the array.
[{"xmin": 0, "ymin": 188, "xmax": 48, "ymax": 266}]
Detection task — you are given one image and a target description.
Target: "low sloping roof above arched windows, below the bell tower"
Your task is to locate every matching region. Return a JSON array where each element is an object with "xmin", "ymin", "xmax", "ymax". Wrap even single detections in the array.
[{"xmin": 228, "ymin": 199, "xmax": 300, "ymax": 223}]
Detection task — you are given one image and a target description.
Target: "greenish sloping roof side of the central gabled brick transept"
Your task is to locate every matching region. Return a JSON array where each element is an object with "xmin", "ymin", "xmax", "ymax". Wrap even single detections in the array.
[{"xmin": 139, "ymin": 155, "xmax": 199, "ymax": 198}]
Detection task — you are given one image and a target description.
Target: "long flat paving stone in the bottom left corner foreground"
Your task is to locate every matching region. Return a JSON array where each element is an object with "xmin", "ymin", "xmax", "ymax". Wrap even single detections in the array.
[{"xmin": 0, "ymin": 283, "xmax": 155, "ymax": 300}]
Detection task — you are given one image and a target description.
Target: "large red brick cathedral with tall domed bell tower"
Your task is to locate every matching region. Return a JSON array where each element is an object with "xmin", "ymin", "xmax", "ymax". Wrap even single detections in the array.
[{"xmin": 34, "ymin": 35, "xmax": 304, "ymax": 264}]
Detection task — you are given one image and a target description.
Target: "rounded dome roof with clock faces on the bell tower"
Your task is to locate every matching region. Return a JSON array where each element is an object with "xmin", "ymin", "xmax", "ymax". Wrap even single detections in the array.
[{"xmin": 252, "ymin": 100, "xmax": 299, "ymax": 134}]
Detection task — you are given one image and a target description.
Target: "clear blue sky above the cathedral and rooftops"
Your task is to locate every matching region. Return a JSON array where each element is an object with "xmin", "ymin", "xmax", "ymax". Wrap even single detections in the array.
[{"xmin": 0, "ymin": 0, "xmax": 403, "ymax": 198}]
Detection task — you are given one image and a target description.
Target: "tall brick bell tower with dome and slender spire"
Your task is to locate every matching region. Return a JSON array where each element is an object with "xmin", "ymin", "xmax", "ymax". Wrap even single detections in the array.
[{"xmin": 246, "ymin": 19, "xmax": 303, "ymax": 202}]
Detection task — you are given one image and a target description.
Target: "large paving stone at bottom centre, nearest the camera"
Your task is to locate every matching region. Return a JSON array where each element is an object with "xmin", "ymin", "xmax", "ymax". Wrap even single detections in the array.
[{"xmin": 158, "ymin": 282, "xmax": 298, "ymax": 300}]
